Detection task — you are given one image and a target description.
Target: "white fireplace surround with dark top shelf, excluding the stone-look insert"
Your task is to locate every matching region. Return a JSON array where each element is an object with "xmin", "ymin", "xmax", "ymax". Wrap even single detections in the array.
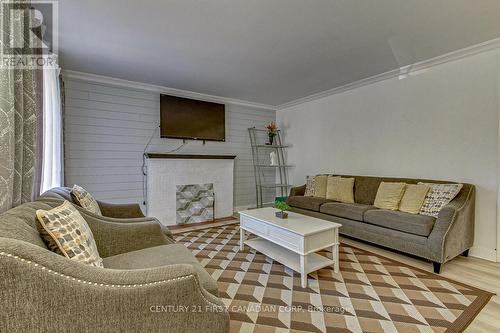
[{"xmin": 146, "ymin": 153, "xmax": 236, "ymax": 225}]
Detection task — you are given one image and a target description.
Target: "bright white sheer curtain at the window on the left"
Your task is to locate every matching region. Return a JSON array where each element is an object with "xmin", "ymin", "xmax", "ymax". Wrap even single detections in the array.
[{"xmin": 40, "ymin": 68, "xmax": 64, "ymax": 194}]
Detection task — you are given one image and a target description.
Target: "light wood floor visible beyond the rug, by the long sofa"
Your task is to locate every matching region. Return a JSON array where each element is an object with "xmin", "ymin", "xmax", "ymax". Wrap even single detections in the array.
[{"xmin": 341, "ymin": 237, "xmax": 500, "ymax": 333}]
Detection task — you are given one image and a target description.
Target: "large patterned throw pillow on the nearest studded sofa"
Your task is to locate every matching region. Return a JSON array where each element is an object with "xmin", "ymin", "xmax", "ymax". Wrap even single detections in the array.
[{"xmin": 36, "ymin": 201, "xmax": 103, "ymax": 267}]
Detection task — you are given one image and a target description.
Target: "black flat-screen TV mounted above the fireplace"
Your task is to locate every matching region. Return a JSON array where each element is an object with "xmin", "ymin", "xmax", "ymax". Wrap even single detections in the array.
[{"xmin": 160, "ymin": 95, "xmax": 226, "ymax": 141}]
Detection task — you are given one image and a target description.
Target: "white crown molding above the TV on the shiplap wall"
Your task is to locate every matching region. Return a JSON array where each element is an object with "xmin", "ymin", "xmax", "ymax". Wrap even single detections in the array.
[{"xmin": 62, "ymin": 70, "xmax": 276, "ymax": 111}]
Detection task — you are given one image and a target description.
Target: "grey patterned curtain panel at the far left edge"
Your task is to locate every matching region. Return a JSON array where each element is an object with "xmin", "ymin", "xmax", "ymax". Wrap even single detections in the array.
[{"xmin": 0, "ymin": 2, "xmax": 39, "ymax": 212}]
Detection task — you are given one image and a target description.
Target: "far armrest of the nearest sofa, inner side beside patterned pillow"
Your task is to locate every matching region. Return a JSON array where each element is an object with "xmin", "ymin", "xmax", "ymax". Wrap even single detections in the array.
[{"xmin": 82, "ymin": 212, "xmax": 173, "ymax": 257}]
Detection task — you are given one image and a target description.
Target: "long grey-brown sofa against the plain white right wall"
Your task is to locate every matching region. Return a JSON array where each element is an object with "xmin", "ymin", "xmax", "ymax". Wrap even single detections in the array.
[{"xmin": 287, "ymin": 175, "xmax": 475, "ymax": 273}]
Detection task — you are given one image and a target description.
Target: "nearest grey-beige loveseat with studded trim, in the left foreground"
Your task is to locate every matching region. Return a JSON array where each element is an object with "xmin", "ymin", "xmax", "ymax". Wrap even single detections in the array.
[{"xmin": 0, "ymin": 197, "xmax": 229, "ymax": 332}]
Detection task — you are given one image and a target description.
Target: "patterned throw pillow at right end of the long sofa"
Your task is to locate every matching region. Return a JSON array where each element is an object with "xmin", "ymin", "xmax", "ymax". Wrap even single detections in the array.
[{"xmin": 418, "ymin": 183, "xmax": 463, "ymax": 217}]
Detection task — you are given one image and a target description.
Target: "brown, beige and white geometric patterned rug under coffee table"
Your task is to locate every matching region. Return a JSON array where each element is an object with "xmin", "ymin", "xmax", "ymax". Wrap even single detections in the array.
[{"xmin": 174, "ymin": 224, "xmax": 492, "ymax": 333}]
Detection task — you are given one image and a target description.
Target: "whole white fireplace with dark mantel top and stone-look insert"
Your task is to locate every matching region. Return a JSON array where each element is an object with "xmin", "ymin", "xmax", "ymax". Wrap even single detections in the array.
[{"xmin": 146, "ymin": 153, "xmax": 235, "ymax": 225}]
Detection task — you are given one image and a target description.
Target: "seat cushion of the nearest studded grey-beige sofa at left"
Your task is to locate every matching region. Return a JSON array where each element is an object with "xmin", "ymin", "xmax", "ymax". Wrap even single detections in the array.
[{"xmin": 103, "ymin": 244, "xmax": 218, "ymax": 296}]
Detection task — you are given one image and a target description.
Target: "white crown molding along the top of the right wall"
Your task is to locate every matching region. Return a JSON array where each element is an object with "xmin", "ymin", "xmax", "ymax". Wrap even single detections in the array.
[{"xmin": 276, "ymin": 38, "xmax": 500, "ymax": 110}]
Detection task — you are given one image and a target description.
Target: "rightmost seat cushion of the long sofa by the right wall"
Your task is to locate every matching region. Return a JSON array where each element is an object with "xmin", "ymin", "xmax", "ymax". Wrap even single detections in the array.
[{"xmin": 364, "ymin": 209, "xmax": 436, "ymax": 237}]
